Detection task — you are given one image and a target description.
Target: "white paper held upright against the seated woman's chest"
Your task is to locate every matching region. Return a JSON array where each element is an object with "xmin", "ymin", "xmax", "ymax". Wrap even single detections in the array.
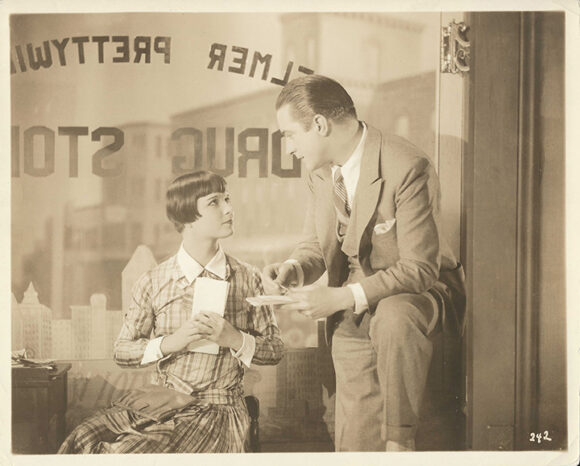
[{"xmin": 187, "ymin": 277, "xmax": 230, "ymax": 354}]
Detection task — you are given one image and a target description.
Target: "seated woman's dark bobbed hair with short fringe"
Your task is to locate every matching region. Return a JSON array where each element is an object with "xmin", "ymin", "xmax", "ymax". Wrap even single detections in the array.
[{"xmin": 166, "ymin": 170, "xmax": 226, "ymax": 233}]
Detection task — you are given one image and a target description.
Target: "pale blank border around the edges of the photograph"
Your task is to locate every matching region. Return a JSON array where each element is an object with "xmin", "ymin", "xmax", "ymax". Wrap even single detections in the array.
[{"xmin": 0, "ymin": 0, "xmax": 580, "ymax": 466}]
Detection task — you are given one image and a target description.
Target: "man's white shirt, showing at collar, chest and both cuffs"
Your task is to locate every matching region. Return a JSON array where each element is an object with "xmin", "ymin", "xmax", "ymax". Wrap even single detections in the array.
[{"xmin": 287, "ymin": 123, "xmax": 369, "ymax": 314}]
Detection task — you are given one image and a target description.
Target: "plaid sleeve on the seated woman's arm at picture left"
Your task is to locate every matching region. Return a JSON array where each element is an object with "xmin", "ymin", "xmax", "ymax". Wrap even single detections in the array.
[{"xmin": 114, "ymin": 273, "xmax": 154, "ymax": 367}]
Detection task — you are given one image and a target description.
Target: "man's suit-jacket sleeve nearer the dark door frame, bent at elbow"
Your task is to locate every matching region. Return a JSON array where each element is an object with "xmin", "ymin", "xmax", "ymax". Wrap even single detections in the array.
[{"xmin": 360, "ymin": 158, "xmax": 440, "ymax": 306}]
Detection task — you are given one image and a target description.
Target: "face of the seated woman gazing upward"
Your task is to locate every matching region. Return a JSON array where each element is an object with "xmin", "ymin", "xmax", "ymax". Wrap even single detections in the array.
[{"xmin": 191, "ymin": 192, "xmax": 234, "ymax": 239}]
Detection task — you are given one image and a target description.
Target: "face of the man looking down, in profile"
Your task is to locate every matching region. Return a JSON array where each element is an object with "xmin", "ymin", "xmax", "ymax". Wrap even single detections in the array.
[{"xmin": 276, "ymin": 104, "xmax": 327, "ymax": 171}]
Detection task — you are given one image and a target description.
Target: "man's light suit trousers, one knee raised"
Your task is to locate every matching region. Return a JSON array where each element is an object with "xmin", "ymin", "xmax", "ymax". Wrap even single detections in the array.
[{"xmin": 332, "ymin": 262, "xmax": 439, "ymax": 451}]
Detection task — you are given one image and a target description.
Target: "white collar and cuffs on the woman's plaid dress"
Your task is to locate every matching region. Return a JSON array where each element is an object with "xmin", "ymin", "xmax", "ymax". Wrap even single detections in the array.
[{"xmin": 141, "ymin": 244, "xmax": 256, "ymax": 367}]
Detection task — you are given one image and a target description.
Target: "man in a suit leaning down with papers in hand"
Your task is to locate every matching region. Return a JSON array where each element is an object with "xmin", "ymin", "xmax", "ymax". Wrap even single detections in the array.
[{"xmin": 264, "ymin": 75, "xmax": 465, "ymax": 451}]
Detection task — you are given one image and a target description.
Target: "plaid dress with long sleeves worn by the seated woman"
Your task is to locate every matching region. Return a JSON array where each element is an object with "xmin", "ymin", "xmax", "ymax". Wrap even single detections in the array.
[{"xmin": 58, "ymin": 255, "xmax": 284, "ymax": 453}]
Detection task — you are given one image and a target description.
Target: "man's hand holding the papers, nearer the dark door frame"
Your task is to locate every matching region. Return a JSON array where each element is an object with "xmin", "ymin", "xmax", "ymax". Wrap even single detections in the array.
[{"xmin": 279, "ymin": 286, "xmax": 354, "ymax": 319}]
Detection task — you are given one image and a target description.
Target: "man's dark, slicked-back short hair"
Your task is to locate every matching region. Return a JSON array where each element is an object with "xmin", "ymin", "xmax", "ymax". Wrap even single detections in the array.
[{"xmin": 276, "ymin": 74, "xmax": 357, "ymax": 131}]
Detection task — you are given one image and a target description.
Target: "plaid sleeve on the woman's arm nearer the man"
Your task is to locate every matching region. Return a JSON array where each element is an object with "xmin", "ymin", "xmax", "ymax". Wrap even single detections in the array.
[{"xmin": 249, "ymin": 272, "xmax": 285, "ymax": 365}]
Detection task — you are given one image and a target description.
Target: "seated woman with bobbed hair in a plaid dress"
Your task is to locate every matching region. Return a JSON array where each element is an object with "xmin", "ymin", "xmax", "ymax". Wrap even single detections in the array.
[{"xmin": 59, "ymin": 171, "xmax": 284, "ymax": 453}]
